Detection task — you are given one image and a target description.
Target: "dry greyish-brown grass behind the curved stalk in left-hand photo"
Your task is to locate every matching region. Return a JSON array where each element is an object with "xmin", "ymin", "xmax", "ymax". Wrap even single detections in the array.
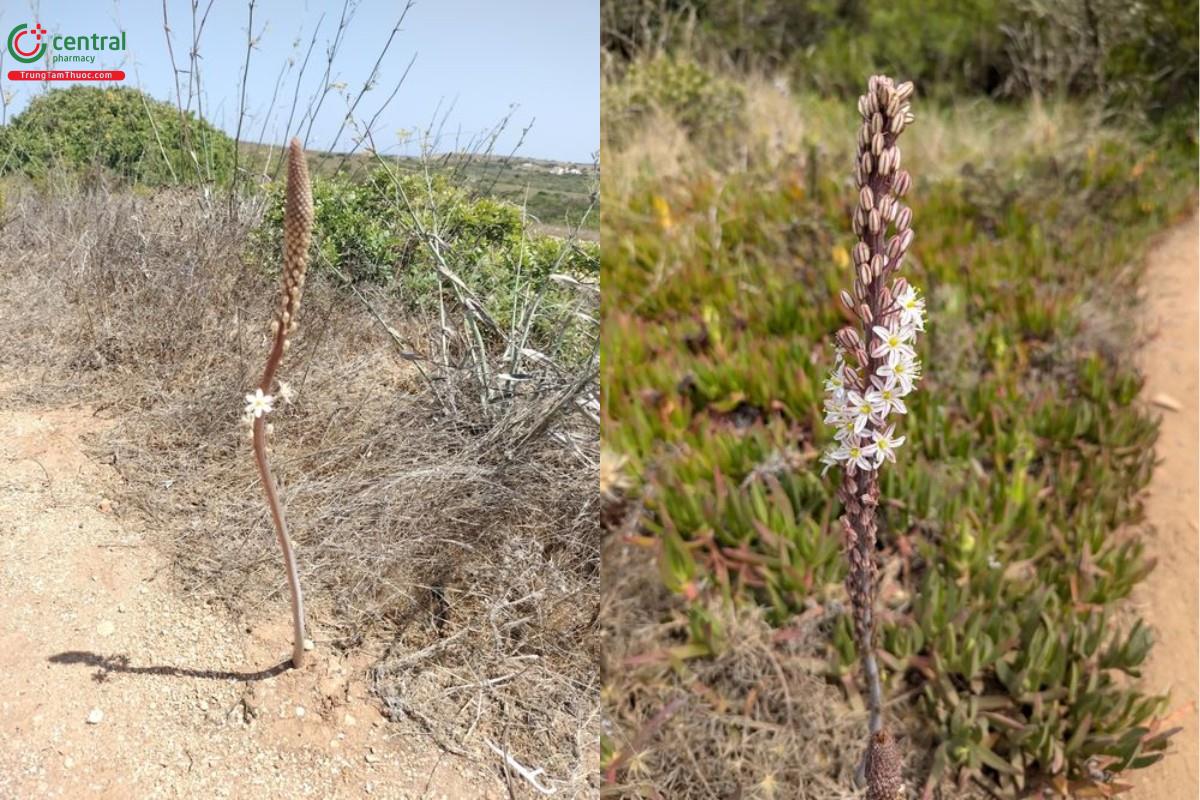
[{"xmin": 0, "ymin": 178, "xmax": 599, "ymax": 796}]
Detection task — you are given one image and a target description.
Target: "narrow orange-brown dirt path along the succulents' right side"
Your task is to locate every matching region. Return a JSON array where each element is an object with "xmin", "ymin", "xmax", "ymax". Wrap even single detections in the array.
[{"xmin": 1129, "ymin": 217, "xmax": 1200, "ymax": 800}]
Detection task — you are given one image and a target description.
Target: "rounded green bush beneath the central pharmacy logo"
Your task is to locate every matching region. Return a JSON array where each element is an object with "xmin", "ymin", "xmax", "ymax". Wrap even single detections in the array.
[{"xmin": 0, "ymin": 86, "xmax": 233, "ymax": 185}]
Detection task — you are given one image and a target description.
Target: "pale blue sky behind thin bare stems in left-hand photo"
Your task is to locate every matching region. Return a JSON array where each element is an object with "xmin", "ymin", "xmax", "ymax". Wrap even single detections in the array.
[{"xmin": 0, "ymin": 0, "xmax": 600, "ymax": 161}]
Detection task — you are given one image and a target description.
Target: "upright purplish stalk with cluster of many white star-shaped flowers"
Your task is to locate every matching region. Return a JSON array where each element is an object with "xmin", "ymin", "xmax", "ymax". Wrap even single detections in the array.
[{"xmin": 822, "ymin": 76, "xmax": 925, "ymax": 800}]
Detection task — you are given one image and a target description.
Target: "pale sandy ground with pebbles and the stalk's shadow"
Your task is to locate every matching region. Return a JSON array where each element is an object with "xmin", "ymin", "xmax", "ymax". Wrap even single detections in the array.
[{"xmin": 0, "ymin": 398, "xmax": 509, "ymax": 800}]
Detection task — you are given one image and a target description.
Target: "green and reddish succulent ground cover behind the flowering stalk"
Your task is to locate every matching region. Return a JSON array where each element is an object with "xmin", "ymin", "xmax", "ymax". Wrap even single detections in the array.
[{"xmin": 601, "ymin": 65, "xmax": 1195, "ymax": 796}]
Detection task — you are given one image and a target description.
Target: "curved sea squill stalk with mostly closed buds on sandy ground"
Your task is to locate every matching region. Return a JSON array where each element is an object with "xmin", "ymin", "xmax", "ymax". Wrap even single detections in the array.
[{"xmin": 246, "ymin": 139, "xmax": 313, "ymax": 668}]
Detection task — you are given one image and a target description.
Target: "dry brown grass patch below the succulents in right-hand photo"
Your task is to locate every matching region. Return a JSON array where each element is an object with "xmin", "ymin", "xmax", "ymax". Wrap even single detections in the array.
[{"xmin": 601, "ymin": 535, "xmax": 945, "ymax": 800}]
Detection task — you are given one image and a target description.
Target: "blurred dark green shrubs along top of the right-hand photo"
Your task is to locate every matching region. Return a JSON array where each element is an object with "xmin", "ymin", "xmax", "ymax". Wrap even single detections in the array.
[{"xmin": 601, "ymin": 0, "xmax": 1200, "ymax": 118}]
